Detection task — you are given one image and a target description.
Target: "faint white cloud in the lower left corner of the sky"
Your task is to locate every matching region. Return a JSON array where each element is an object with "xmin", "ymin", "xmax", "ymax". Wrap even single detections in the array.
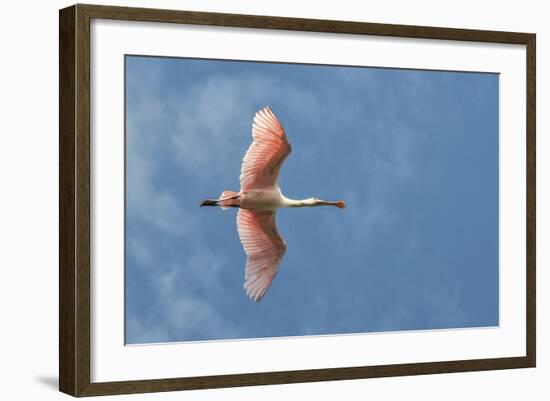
[{"xmin": 127, "ymin": 246, "xmax": 242, "ymax": 344}]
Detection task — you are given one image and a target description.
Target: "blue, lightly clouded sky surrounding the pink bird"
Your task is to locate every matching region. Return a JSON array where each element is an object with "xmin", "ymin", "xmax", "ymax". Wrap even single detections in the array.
[{"xmin": 125, "ymin": 56, "xmax": 499, "ymax": 344}]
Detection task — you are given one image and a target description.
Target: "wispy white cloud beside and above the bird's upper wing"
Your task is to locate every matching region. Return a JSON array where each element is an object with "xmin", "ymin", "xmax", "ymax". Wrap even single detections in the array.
[{"xmin": 170, "ymin": 75, "xmax": 318, "ymax": 178}]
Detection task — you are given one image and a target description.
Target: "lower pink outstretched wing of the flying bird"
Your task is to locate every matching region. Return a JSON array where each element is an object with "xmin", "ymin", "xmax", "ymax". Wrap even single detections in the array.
[{"xmin": 237, "ymin": 209, "xmax": 286, "ymax": 302}]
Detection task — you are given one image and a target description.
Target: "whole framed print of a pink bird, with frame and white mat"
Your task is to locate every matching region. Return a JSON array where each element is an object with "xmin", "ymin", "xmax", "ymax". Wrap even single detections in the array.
[{"xmin": 59, "ymin": 5, "xmax": 536, "ymax": 396}]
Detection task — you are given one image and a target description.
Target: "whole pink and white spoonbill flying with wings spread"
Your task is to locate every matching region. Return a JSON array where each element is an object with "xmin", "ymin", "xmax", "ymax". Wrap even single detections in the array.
[{"xmin": 200, "ymin": 106, "xmax": 346, "ymax": 302}]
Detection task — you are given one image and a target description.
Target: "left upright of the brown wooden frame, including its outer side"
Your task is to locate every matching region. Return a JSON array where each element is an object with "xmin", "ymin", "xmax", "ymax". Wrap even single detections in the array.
[{"xmin": 59, "ymin": 6, "xmax": 90, "ymax": 396}]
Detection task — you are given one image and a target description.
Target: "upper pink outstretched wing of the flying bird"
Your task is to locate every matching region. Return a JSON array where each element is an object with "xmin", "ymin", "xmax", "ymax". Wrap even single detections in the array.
[{"xmin": 240, "ymin": 107, "xmax": 291, "ymax": 191}]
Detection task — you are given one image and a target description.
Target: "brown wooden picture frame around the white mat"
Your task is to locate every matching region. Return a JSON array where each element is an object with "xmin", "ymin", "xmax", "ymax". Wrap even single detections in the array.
[{"xmin": 59, "ymin": 4, "xmax": 536, "ymax": 396}]
